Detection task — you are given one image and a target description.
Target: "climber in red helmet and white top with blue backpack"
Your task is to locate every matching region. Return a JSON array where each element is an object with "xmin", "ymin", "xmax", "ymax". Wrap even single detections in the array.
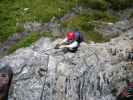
[{"xmin": 56, "ymin": 31, "xmax": 83, "ymax": 52}]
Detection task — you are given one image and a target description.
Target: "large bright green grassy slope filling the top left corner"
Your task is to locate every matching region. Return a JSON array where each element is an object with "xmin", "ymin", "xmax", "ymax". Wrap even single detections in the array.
[{"xmin": 0, "ymin": 0, "xmax": 76, "ymax": 43}]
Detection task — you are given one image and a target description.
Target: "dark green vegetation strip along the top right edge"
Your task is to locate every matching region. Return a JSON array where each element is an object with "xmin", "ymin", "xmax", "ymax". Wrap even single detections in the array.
[{"xmin": 79, "ymin": 0, "xmax": 133, "ymax": 10}]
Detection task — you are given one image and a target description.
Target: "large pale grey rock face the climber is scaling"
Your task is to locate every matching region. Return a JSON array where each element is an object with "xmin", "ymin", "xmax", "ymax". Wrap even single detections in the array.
[{"xmin": 0, "ymin": 38, "xmax": 133, "ymax": 100}]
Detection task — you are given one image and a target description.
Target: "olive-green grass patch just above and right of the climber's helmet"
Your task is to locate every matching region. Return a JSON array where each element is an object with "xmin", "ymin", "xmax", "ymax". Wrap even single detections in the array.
[{"xmin": 62, "ymin": 11, "xmax": 118, "ymax": 42}]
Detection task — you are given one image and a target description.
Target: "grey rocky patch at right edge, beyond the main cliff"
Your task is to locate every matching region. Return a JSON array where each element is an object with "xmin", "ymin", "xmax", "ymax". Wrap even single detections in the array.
[{"xmin": 96, "ymin": 19, "xmax": 133, "ymax": 39}]
